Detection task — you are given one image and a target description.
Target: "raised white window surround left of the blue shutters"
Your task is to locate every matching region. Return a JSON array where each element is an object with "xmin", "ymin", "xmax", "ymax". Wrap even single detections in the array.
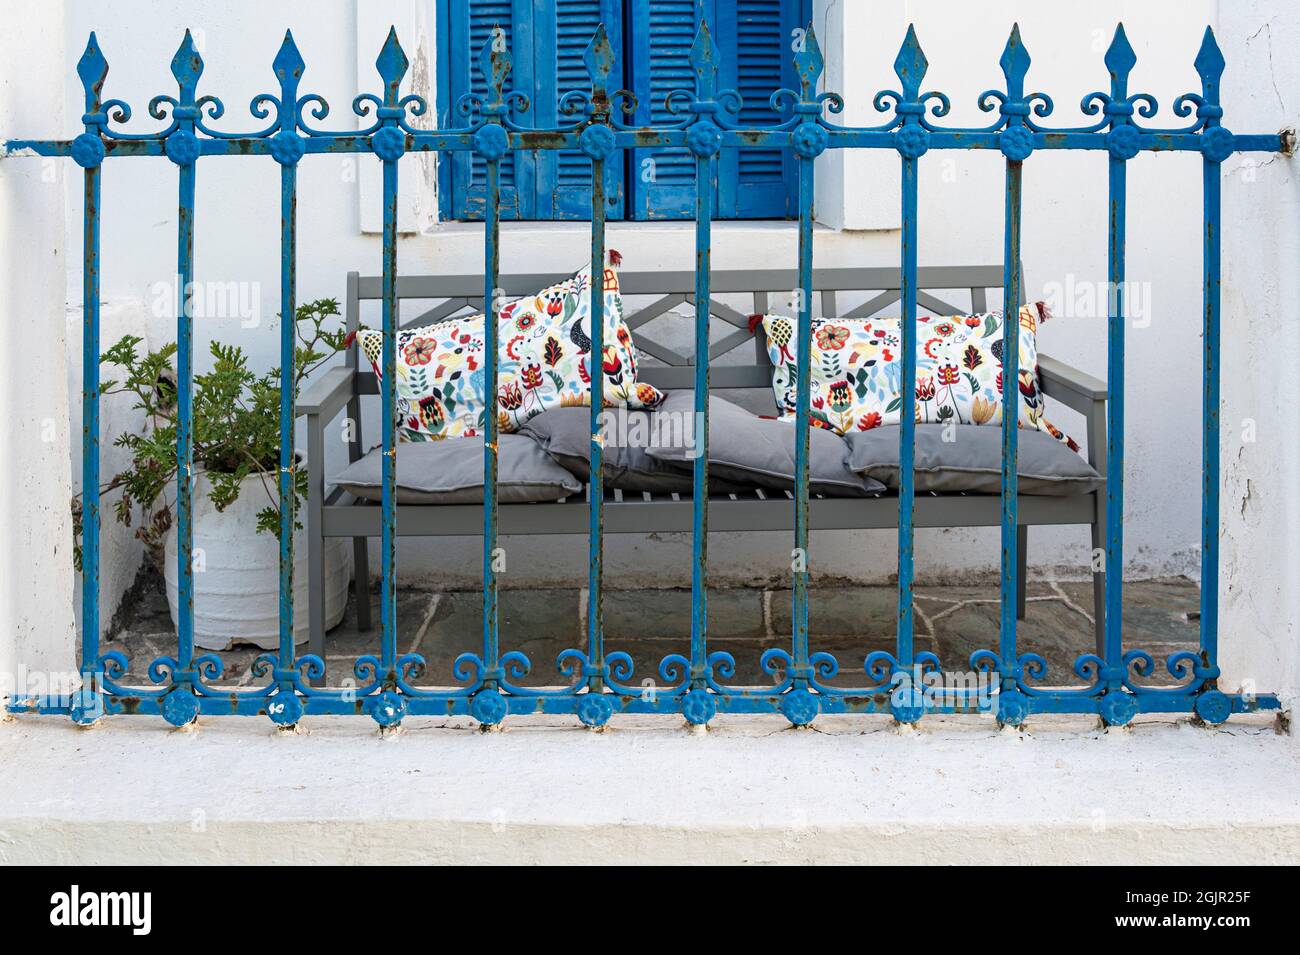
[{"xmin": 356, "ymin": 0, "xmax": 438, "ymax": 234}]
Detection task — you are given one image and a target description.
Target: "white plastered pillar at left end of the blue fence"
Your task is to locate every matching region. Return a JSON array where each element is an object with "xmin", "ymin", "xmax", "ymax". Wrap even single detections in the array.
[{"xmin": 0, "ymin": 0, "xmax": 75, "ymax": 696}]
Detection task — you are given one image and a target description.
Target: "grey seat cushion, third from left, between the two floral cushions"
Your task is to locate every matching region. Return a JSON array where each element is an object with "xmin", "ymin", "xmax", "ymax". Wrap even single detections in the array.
[{"xmin": 649, "ymin": 391, "xmax": 884, "ymax": 498}]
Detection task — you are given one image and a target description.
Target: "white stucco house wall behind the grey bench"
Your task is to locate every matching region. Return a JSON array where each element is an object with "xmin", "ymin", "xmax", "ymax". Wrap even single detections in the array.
[{"xmin": 45, "ymin": 0, "xmax": 1282, "ymax": 608}]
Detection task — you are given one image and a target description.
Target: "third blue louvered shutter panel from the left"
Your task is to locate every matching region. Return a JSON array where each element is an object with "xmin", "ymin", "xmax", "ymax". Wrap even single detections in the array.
[{"xmin": 627, "ymin": 0, "xmax": 714, "ymax": 220}]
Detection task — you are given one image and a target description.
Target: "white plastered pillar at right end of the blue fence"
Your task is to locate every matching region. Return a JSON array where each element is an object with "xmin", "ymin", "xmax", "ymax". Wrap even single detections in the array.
[{"xmin": 1219, "ymin": 0, "xmax": 1300, "ymax": 700}]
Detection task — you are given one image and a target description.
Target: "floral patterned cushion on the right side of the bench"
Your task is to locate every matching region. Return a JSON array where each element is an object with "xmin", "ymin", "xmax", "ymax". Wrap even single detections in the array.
[{"xmin": 762, "ymin": 303, "xmax": 1078, "ymax": 450}]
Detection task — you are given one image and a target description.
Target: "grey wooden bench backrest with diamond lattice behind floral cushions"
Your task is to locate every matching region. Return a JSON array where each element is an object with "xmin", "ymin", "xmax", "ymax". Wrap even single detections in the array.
[{"xmin": 346, "ymin": 265, "xmax": 1023, "ymax": 394}]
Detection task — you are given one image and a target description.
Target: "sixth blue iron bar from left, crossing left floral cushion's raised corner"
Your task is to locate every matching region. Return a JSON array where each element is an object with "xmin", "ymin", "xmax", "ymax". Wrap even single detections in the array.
[{"xmin": 586, "ymin": 159, "xmax": 605, "ymax": 693}]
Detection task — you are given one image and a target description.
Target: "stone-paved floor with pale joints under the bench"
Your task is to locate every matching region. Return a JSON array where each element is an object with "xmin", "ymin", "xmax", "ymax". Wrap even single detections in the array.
[{"xmin": 107, "ymin": 566, "xmax": 1200, "ymax": 686}]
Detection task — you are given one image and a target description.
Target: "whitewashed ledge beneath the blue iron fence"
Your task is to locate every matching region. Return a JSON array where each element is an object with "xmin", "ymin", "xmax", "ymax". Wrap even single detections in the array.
[{"xmin": 0, "ymin": 715, "xmax": 1300, "ymax": 864}]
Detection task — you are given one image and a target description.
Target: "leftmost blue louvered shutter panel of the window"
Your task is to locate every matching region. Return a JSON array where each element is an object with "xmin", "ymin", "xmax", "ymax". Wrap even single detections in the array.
[{"xmin": 446, "ymin": 0, "xmax": 537, "ymax": 220}]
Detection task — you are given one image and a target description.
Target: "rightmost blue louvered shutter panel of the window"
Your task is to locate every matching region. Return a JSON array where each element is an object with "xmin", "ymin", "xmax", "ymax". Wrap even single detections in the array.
[{"xmin": 716, "ymin": 0, "xmax": 807, "ymax": 218}]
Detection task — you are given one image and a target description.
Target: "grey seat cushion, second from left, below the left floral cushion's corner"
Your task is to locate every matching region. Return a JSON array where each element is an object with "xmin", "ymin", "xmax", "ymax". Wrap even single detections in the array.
[{"xmin": 519, "ymin": 407, "xmax": 741, "ymax": 494}]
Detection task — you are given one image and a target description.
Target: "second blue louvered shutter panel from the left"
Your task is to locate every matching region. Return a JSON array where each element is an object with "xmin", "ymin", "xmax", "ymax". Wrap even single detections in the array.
[{"xmin": 532, "ymin": 0, "xmax": 624, "ymax": 220}]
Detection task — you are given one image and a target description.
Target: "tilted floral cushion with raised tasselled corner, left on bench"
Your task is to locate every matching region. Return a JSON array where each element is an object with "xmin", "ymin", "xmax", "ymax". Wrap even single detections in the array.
[{"xmin": 356, "ymin": 261, "xmax": 663, "ymax": 440}]
